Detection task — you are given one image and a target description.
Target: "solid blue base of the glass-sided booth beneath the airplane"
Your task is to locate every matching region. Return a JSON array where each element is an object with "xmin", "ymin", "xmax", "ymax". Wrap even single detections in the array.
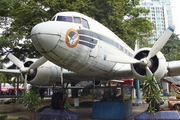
[{"xmin": 92, "ymin": 100, "xmax": 132, "ymax": 120}]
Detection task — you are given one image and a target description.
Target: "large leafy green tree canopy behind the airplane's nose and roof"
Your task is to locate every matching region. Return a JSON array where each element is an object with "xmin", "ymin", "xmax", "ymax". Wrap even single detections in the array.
[{"xmin": 0, "ymin": 0, "xmax": 153, "ymax": 63}]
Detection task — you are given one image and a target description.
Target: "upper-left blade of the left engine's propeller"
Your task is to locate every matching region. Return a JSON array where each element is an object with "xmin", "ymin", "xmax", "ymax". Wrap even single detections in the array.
[{"xmin": 6, "ymin": 52, "xmax": 24, "ymax": 68}]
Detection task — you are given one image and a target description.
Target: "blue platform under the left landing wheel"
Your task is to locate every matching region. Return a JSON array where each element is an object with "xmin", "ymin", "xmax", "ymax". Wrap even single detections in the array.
[{"xmin": 40, "ymin": 108, "xmax": 79, "ymax": 120}]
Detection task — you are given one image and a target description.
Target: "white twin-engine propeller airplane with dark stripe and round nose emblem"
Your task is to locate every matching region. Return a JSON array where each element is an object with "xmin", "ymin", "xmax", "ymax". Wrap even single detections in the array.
[{"xmin": 0, "ymin": 11, "xmax": 180, "ymax": 109}]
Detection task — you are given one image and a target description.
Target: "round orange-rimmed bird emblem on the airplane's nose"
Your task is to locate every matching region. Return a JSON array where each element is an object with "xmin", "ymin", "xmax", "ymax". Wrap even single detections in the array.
[{"xmin": 66, "ymin": 28, "xmax": 79, "ymax": 48}]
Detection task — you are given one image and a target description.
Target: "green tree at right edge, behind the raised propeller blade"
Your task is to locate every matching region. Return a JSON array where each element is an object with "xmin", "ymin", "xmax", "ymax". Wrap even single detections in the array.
[{"xmin": 161, "ymin": 33, "xmax": 180, "ymax": 61}]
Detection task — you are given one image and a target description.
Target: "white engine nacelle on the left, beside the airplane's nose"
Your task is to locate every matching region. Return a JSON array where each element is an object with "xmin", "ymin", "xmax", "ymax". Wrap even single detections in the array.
[{"xmin": 22, "ymin": 59, "xmax": 61, "ymax": 85}]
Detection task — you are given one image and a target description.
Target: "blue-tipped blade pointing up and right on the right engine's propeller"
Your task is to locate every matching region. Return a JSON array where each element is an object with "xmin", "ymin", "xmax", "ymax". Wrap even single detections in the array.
[{"xmin": 147, "ymin": 25, "xmax": 175, "ymax": 60}]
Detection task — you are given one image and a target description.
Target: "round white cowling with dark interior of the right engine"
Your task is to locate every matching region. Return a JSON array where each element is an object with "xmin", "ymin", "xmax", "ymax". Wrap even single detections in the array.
[{"xmin": 131, "ymin": 48, "xmax": 167, "ymax": 81}]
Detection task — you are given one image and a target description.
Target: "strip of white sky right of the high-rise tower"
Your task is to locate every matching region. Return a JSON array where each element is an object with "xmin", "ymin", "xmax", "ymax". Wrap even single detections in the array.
[{"xmin": 171, "ymin": 0, "xmax": 180, "ymax": 37}]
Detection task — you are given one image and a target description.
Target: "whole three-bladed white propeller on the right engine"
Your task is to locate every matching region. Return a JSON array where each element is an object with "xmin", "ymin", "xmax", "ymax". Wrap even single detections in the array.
[{"xmin": 104, "ymin": 25, "xmax": 175, "ymax": 76}]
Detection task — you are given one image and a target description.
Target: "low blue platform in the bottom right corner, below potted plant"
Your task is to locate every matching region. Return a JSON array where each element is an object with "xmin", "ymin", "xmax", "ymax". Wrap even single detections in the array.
[{"xmin": 134, "ymin": 111, "xmax": 180, "ymax": 120}]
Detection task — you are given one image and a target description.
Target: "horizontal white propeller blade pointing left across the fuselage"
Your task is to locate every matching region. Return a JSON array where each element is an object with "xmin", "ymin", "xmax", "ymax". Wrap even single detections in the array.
[{"xmin": 104, "ymin": 55, "xmax": 140, "ymax": 64}]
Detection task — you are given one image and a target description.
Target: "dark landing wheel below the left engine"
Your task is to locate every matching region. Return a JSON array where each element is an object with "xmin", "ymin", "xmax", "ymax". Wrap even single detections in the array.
[{"xmin": 51, "ymin": 92, "xmax": 64, "ymax": 110}]
